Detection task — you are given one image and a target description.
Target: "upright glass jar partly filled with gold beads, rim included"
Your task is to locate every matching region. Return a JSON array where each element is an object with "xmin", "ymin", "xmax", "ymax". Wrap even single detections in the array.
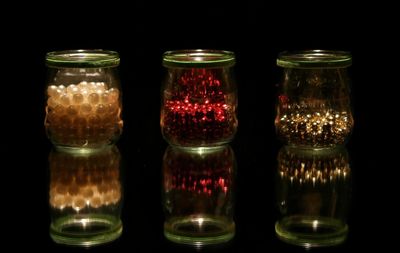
[{"xmin": 275, "ymin": 50, "xmax": 353, "ymax": 147}]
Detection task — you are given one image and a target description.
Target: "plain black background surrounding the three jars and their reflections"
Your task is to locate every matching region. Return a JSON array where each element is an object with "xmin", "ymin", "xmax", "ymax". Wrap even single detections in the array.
[{"xmin": 2, "ymin": 1, "xmax": 398, "ymax": 252}]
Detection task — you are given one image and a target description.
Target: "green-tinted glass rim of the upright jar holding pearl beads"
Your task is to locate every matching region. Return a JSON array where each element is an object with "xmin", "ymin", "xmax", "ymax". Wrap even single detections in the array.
[{"xmin": 46, "ymin": 49, "xmax": 120, "ymax": 68}]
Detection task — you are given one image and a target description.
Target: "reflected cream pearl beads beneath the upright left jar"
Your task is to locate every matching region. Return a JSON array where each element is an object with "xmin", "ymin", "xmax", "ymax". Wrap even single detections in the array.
[{"xmin": 49, "ymin": 147, "xmax": 121, "ymax": 211}]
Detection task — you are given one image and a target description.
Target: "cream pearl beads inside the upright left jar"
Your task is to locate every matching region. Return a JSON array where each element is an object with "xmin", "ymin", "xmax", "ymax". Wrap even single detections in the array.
[{"xmin": 45, "ymin": 82, "xmax": 123, "ymax": 147}]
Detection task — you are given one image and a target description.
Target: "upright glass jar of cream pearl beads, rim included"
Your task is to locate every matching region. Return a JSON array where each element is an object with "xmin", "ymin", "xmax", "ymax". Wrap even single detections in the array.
[{"xmin": 45, "ymin": 50, "xmax": 123, "ymax": 151}]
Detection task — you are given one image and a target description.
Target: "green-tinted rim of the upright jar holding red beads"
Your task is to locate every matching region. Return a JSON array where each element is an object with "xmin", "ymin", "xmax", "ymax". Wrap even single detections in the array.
[{"xmin": 163, "ymin": 49, "xmax": 235, "ymax": 68}]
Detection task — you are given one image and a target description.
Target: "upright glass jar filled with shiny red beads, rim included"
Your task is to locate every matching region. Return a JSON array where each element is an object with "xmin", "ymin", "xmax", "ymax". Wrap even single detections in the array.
[{"xmin": 160, "ymin": 49, "xmax": 238, "ymax": 147}]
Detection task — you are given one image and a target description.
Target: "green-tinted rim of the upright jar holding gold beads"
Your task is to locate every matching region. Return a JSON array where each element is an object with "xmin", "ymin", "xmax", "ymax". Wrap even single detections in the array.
[{"xmin": 276, "ymin": 50, "xmax": 352, "ymax": 68}]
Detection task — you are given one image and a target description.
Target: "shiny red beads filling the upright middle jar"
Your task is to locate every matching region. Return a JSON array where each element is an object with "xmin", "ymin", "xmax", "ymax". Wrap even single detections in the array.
[{"xmin": 161, "ymin": 69, "xmax": 237, "ymax": 146}]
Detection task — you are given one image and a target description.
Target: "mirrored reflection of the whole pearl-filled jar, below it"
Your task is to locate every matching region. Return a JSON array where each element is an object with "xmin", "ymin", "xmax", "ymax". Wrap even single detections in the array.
[{"xmin": 49, "ymin": 146, "xmax": 123, "ymax": 247}]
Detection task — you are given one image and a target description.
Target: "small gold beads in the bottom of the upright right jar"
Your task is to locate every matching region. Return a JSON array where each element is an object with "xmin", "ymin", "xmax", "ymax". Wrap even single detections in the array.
[{"xmin": 275, "ymin": 109, "xmax": 353, "ymax": 147}]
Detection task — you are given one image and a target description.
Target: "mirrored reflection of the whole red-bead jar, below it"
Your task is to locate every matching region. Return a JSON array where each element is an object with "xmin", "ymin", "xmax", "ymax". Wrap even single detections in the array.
[{"xmin": 163, "ymin": 146, "xmax": 236, "ymax": 247}]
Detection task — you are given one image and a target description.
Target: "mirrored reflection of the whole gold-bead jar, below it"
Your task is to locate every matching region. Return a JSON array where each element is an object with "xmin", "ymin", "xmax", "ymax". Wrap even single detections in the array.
[{"xmin": 275, "ymin": 146, "xmax": 351, "ymax": 248}]
